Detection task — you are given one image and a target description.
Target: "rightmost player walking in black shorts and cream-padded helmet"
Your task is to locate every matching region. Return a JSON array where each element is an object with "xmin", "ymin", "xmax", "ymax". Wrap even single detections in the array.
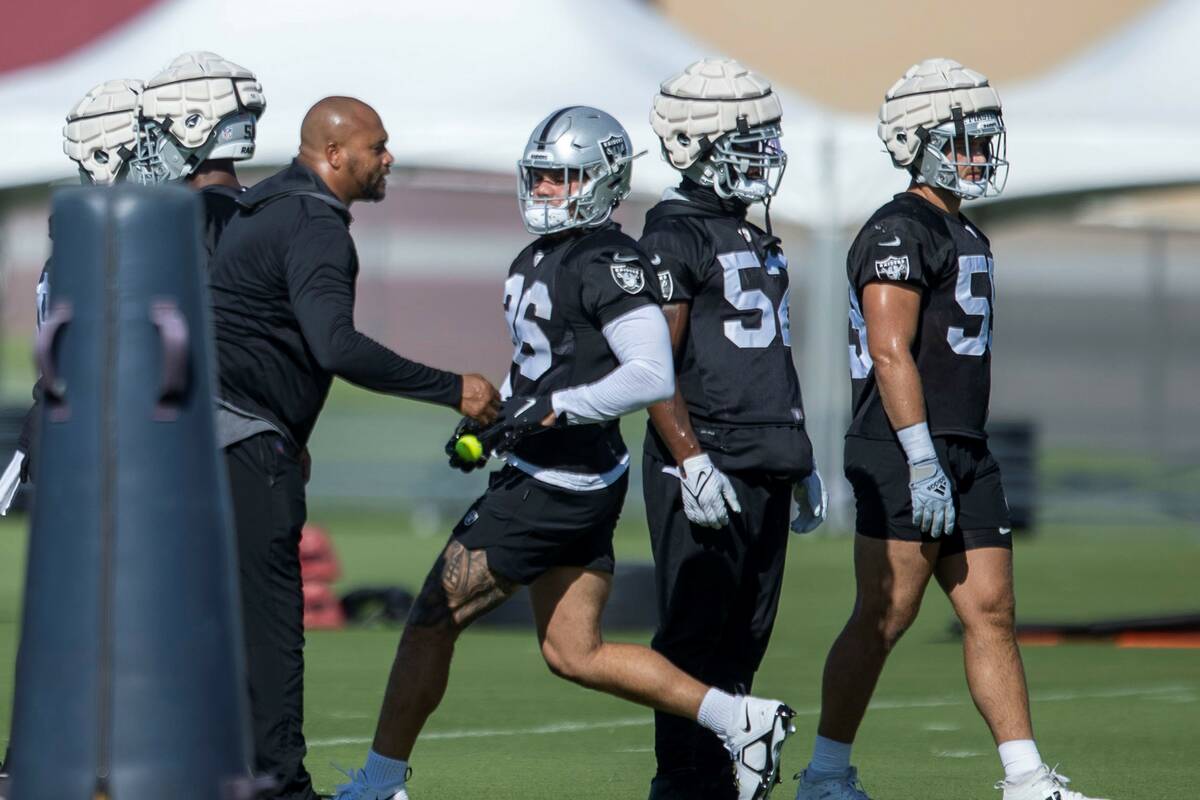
[{"xmin": 796, "ymin": 59, "xmax": 1104, "ymax": 800}]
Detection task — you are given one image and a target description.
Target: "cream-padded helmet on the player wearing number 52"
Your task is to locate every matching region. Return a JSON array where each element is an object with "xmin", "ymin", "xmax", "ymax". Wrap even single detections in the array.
[{"xmin": 650, "ymin": 58, "xmax": 787, "ymax": 203}]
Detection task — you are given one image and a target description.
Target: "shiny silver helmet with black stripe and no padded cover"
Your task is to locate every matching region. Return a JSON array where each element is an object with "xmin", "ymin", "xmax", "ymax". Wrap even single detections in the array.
[{"xmin": 517, "ymin": 106, "xmax": 646, "ymax": 235}]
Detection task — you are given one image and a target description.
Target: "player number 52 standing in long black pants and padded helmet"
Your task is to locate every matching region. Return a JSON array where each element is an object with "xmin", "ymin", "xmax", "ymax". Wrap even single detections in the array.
[{"xmin": 640, "ymin": 59, "xmax": 824, "ymax": 800}]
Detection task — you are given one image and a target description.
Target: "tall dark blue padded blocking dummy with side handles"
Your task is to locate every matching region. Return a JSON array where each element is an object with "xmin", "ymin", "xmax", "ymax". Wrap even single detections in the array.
[{"xmin": 10, "ymin": 186, "xmax": 256, "ymax": 800}]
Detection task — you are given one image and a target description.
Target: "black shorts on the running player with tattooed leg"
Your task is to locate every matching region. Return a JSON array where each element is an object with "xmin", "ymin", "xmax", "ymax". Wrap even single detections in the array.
[{"xmin": 454, "ymin": 467, "xmax": 629, "ymax": 584}]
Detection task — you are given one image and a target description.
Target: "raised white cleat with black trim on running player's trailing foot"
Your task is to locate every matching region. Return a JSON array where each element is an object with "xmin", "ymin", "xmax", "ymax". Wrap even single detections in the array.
[{"xmin": 725, "ymin": 697, "xmax": 796, "ymax": 800}]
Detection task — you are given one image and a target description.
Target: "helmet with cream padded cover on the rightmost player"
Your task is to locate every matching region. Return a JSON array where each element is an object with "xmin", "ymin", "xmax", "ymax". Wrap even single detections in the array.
[{"xmin": 878, "ymin": 59, "xmax": 1008, "ymax": 199}]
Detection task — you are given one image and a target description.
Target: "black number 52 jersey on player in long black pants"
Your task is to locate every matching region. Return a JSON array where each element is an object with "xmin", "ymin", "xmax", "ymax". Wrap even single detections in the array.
[{"xmin": 640, "ymin": 182, "xmax": 811, "ymax": 473}]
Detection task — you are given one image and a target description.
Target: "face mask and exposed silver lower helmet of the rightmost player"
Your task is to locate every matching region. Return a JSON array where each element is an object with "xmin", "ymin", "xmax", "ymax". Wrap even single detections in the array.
[{"xmin": 913, "ymin": 109, "xmax": 1008, "ymax": 200}]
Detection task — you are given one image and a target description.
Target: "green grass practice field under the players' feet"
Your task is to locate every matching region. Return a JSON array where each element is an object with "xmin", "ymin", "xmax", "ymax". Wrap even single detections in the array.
[{"xmin": 0, "ymin": 506, "xmax": 1200, "ymax": 800}]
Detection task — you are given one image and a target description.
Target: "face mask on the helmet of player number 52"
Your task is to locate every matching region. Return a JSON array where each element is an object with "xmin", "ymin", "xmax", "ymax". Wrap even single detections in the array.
[{"xmin": 684, "ymin": 122, "xmax": 787, "ymax": 204}]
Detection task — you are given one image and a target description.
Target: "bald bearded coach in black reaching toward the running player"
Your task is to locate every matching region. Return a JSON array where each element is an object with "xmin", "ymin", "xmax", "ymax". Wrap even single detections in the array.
[{"xmin": 209, "ymin": 97, "xmax": 499, "ymax": 800}]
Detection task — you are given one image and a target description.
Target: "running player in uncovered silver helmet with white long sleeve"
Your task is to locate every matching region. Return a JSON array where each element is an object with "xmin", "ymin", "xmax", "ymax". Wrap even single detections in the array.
[{"xmin": 336, "ymin": 106, "xmax": 792, "ymax": 800}]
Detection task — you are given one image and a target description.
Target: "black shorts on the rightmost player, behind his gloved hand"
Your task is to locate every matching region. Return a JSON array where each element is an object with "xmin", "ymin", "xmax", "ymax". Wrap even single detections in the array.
[{"xmin": 845, "ymin": 437, "xmax": 1013, "ymax": 558}]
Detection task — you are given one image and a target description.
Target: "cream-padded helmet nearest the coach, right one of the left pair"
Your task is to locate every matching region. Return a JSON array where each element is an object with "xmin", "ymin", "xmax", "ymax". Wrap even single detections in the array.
[{"xmin": 133, "ymin": 50, "xmax": 266, "ymax": 184}]
